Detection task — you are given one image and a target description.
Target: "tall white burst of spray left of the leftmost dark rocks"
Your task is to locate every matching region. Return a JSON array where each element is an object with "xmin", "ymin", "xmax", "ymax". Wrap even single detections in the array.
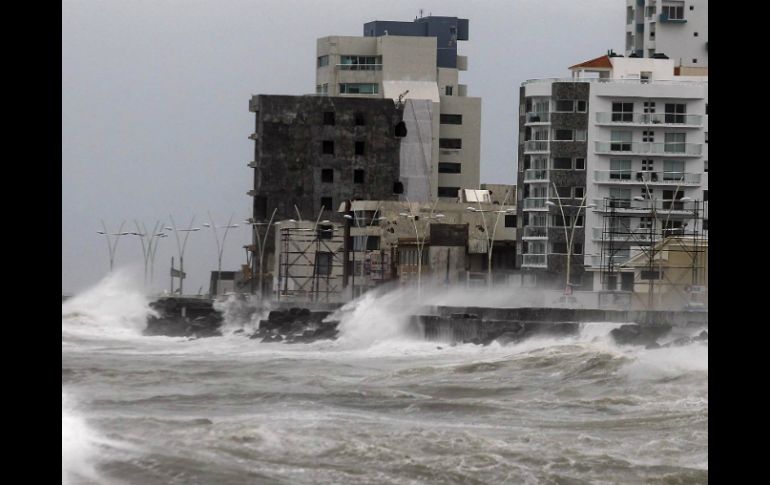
[{"xmin": 62, "ymin": 269, "xmax": 155, "ymax": 337}]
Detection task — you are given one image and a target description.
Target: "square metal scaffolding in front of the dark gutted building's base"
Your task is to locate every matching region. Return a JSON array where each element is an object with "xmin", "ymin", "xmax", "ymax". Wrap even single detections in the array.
[{"xmin": 277, "ymin": 226, "xmax": 344, "ymax": 302}]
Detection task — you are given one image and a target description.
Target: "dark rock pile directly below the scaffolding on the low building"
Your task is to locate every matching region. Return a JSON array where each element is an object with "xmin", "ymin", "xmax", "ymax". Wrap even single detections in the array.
[{"xmin": 251, "ymin": 308, "xmax": 339, "ymax": 343}]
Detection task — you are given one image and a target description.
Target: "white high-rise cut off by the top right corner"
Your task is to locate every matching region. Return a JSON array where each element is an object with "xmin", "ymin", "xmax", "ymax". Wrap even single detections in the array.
[{"xmin": 626, "ymin": 0, "xmax": 708, "ymax": 70}]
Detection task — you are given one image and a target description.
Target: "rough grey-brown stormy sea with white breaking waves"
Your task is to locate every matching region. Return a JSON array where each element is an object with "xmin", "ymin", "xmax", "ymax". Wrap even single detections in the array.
[{"xmin": 62, "ymin": 274, "xmax": 708, "ymax": 485}]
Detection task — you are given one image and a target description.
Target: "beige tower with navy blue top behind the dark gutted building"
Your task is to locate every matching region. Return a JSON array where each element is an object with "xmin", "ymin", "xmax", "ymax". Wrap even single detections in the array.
[{"xmin": 316, "ymin": 17, "xmax": 481, "ymax": 201}]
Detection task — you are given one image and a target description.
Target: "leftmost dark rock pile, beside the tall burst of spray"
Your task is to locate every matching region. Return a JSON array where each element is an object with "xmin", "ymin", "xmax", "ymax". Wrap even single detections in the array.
[{"xmin": 144, "ymin": 297, "xmax": 224, "ymax": 338}]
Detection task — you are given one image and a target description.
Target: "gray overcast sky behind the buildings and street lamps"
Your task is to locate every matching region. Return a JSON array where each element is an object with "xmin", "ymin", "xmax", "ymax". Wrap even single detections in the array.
[{"xmin": 62, "ymin": 0, "xmax": 625, "ymax": 293}]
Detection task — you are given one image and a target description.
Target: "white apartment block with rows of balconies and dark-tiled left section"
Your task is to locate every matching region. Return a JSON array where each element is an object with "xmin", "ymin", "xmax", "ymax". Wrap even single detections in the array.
[{"xmin": 518, "ymin": 56, "xmax": 708, "ymax": 290}]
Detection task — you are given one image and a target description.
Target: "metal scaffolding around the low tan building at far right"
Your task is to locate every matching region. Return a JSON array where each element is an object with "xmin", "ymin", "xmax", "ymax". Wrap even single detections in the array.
[{"xmin": 599, "ymin": 197, "xmax": 708, "ymax": 309}]
